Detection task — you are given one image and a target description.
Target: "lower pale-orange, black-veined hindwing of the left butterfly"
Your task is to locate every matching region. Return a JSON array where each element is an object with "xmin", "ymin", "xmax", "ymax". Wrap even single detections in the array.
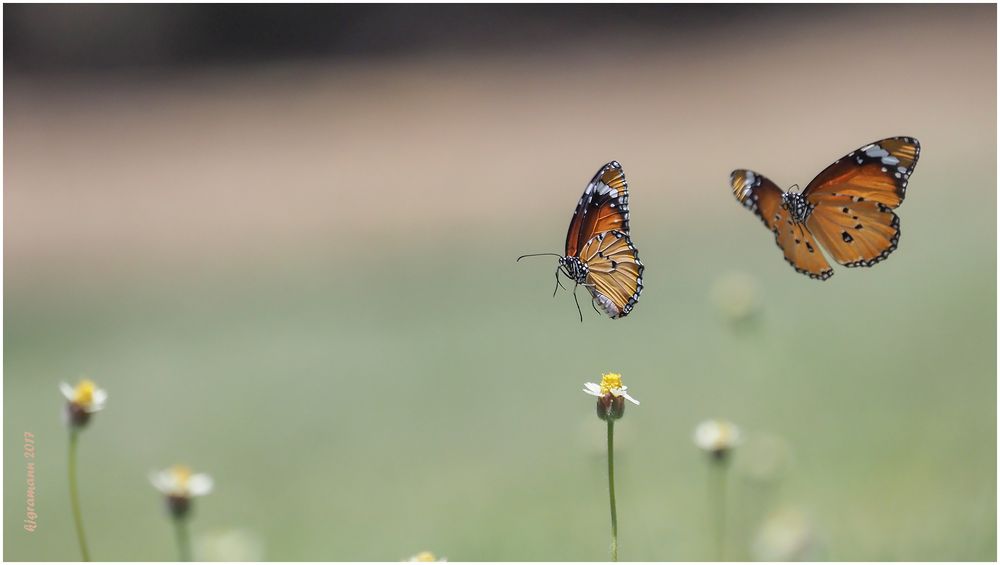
[{"xmin": 580, "ymin": 231, "xmax": 644, "ymax": 318}]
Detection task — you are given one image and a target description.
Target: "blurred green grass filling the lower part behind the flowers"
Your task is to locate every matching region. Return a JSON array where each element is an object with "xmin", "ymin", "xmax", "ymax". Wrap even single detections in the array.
[{"xmin": 4, "ymin": 213, "xmax": 996, "ymax": 560}]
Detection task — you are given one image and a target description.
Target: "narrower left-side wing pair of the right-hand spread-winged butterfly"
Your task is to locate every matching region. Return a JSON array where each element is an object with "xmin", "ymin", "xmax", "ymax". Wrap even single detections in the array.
[{"xmin": 729, "ymin": 169, "xmax": 833, "ymax": 280}]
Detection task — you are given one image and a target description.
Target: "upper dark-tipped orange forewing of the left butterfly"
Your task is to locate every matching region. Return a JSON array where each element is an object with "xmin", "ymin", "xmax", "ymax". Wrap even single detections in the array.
[{"xmin": 566, "ymin": 161, "xmax": 629, "ymax": 257}]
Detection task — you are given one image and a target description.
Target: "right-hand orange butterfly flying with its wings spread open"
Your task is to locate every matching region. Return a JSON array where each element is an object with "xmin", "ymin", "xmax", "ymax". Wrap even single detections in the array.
[{"xmin": 729, "ymin": 137, "xmax": 920, "ymax": 280}]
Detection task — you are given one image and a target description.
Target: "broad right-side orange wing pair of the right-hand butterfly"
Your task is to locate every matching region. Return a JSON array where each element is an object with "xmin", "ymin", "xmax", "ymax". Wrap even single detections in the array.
[{"xmin": 802, "ymin": 137, "xmax": 920, "ymax": 267}]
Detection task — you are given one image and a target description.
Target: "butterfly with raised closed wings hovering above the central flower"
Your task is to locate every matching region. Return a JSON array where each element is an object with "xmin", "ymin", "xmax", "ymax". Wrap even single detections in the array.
[{"xmin": 517, "ymin": 161, "xmax": 644, "ymax": 322}]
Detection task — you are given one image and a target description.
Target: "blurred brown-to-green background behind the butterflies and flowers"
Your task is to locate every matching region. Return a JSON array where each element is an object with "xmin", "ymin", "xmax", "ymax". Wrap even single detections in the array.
[{"xmin": 3, "ymin": 5, "xmax": 997, "ymax": 561}]
